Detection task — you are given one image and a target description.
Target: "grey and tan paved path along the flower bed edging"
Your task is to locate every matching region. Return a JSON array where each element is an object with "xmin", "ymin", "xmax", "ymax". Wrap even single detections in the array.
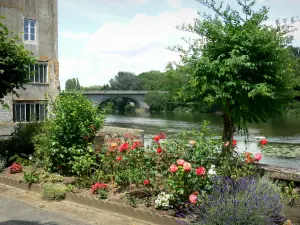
[{"xmin": 0, "ymin": 184, "xmax": 153, "ymax": 225}]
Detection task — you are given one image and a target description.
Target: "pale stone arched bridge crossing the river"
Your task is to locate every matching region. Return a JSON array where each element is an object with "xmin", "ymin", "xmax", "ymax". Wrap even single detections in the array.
[{"xmin": 81, "ymin": 90, "xmax": 168, "ymax": 109}]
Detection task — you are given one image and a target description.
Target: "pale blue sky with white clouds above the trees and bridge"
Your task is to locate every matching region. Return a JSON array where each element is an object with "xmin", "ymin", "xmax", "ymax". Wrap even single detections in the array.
[{"xmin": 58, "ymin": 0, "xmax": 300, "ymax": 89}]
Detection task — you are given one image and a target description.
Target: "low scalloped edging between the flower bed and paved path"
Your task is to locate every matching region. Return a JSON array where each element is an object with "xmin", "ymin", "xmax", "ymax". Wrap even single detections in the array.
[{"xmin": 0, "ymin": 176, "xmax": 180, "ymax": 225}]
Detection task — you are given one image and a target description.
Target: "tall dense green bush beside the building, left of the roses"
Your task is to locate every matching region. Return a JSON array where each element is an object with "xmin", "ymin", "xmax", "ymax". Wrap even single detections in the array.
[{"xmin": 34, "ymin": 93, "xmax": 104, "ymax": 172}]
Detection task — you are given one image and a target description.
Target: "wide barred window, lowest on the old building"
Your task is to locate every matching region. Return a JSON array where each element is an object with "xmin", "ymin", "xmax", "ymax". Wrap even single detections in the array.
[{"xmin": 13, "ymin": 101, "xmax": 48, "ymax": 122}]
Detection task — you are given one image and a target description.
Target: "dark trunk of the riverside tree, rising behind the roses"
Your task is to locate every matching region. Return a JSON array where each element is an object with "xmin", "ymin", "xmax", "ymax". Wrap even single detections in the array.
[{"xmin": 222, "ymin": 114, "xmax": 235, "ymax": 155}]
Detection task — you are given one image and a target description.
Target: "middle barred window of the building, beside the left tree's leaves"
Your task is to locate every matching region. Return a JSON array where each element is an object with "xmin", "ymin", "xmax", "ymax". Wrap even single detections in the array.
[{"xmin": 29, "ymin": 62, "xmax": 48, "ymax": 83}]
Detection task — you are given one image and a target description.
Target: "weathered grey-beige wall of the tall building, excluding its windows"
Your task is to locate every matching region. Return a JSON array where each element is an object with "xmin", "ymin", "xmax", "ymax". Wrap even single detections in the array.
[{"xmin": 0, "ymin": 0, "xmax": 60, "ymax": 122}]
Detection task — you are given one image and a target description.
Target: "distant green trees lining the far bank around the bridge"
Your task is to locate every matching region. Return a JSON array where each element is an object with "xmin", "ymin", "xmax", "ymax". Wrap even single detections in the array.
[{"xmin": 65, "ymin": 46, "xmax": 300, "ymax": 114}]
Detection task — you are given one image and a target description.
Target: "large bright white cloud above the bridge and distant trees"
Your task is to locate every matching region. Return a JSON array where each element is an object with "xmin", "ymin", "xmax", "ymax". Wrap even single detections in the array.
[{"xmin": 60, "ymin": 8, "xmax": 197, "ymax": 87}]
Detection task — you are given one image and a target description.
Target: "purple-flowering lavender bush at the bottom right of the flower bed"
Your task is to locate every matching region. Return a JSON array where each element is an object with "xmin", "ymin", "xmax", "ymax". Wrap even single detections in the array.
[{"xmin": 194, "ymin": 177, "xmax": 284, "ymax": 225}]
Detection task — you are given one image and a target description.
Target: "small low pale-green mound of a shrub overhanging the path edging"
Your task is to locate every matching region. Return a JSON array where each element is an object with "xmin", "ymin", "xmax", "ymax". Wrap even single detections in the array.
[{"xmin": 43, "ymin": 183, "xmax": 67, "ymax": 201}]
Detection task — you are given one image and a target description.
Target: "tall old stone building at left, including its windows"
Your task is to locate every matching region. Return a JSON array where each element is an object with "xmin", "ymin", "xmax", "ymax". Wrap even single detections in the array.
[{"xmin": 0, "ymin": 0, "xmax": 60, "ymax": 123}]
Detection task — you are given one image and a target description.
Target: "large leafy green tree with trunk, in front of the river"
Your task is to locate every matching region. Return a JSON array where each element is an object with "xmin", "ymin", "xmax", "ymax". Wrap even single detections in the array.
[{"xmin": 176, "ymin": 0, "xmax": 293, "ymax": 152}]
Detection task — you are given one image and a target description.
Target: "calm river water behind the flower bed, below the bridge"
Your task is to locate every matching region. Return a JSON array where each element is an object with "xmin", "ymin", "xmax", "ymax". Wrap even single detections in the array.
[{"xmin": 105, "ymin": 113, "xmax": 300, "ymax": 169}]
